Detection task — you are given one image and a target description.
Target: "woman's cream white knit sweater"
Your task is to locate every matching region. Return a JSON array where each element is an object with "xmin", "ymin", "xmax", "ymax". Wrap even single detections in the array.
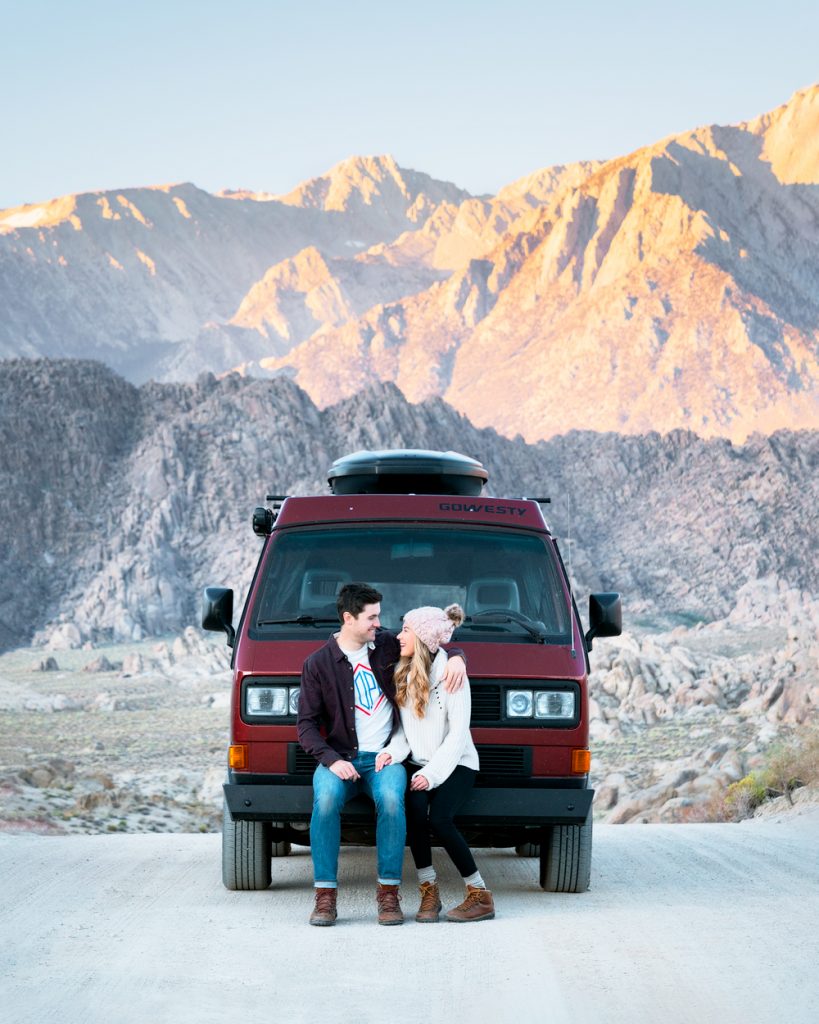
[{"xmin": 384, "ymin": 648, "xmax": 479, "ymax": 790}]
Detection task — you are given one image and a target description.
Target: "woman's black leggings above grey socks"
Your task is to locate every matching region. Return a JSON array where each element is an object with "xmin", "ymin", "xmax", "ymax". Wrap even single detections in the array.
[{"xmin": 405, "ymin": 763, "xmax": 478, "ymax": 879}]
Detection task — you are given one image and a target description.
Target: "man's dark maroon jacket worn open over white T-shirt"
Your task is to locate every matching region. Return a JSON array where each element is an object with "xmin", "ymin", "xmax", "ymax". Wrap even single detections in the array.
[{"xmin": 297, "ymin": 630, "xmax": 464, "ymax": 768}]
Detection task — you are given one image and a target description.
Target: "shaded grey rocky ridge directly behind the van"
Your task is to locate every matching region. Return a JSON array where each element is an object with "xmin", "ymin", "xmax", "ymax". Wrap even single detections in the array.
[{"xmin": 0, "ymin": 359, "xmax": 819, "ymax": 648}]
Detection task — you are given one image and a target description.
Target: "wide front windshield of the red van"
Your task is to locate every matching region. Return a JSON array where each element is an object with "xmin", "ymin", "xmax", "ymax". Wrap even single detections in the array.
[{"xmin": 249, "ymin": 524, "xmax": 569, "ymax": 644}]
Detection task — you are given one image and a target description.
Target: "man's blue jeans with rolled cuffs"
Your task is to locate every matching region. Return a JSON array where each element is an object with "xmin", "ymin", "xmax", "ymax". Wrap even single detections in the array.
[{"xmin": 310, "ymin": 751, "xmax": 406, "ymax": 889}]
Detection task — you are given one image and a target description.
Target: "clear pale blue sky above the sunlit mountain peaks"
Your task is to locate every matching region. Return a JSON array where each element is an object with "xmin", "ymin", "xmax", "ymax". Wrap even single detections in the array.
[{"xmin": 0, "ymin": 0, "xmax": 819, "ymax": 208}]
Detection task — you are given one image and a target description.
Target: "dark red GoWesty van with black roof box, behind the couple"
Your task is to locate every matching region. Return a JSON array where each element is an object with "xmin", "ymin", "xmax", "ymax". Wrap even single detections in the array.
[{"xmin": 202, "ymin": 451, "xmax": 621, "ymax": 892}]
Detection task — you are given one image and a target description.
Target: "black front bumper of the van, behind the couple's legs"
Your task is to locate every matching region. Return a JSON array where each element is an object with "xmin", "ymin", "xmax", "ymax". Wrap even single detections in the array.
[{"xmin": 224, "ymin": 773, "xmax": 595, "ymax": 826}]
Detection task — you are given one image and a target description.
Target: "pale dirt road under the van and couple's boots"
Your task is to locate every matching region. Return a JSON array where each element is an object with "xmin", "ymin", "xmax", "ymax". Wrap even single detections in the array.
[{"xmin": 0, "ymin": 809, "xmax": 819, "ymax": 1024}]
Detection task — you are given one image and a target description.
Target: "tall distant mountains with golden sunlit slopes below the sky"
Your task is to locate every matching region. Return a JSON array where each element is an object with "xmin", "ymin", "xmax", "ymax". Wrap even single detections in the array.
[{"xmin": 0, "ymin": 86, "xmax": 819, "ymax": 442}]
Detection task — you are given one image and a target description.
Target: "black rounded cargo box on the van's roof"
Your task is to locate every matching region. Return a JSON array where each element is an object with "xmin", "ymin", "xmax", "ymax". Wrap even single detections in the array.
[{"xmin": 327, "ymin": 449, "xmax": 488, "ymax": 497}]
